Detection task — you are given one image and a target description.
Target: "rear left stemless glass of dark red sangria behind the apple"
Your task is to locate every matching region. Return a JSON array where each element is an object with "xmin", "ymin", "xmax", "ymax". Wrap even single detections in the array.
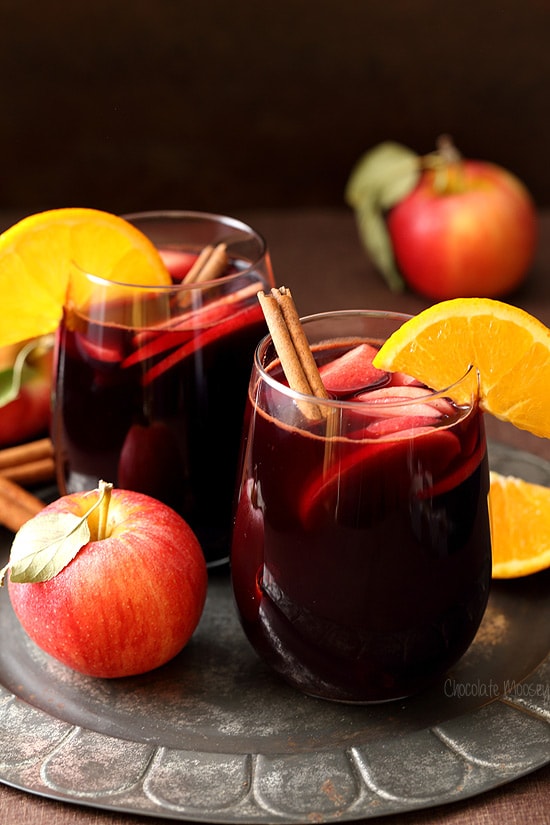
[{"xmin": 52, "ymin": 211, "xmax": 273, "ymax": 566}]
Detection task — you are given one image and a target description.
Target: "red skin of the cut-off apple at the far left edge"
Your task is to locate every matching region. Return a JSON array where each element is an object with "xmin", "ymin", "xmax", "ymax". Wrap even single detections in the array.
[{"xmin": 0, "ymin": 340, "xmax": 52, "ymax": 448}]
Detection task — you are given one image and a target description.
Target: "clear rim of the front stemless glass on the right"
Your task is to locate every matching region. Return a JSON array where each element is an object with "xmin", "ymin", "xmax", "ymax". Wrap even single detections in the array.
[{"xmin": 254, "ymin": 309, "xmax": 479, "ymax": 410}]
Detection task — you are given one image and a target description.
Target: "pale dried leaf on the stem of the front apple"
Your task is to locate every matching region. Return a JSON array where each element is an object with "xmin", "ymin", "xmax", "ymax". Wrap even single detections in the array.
[{"xmin": 9, "ymin": 513, "xmax": 90, "ymax": 582}]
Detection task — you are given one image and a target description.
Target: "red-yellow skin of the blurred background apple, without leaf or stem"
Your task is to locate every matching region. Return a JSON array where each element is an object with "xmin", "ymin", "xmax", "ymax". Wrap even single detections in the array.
[{"xmin": 387, "ymin": 160, "xmax": 537, "ymax": 300}]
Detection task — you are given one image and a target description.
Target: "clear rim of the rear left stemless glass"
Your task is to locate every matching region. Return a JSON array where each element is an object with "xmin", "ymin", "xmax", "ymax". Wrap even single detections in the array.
[{"xmin": 71, "ymin": 209, "xmax": 268, "ymax": 293}]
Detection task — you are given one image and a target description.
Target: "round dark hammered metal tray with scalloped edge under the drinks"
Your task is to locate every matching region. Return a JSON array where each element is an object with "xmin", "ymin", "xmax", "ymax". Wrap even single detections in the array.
[{"xmin": 0, "ymin": 444, "xmax": 550, "ymax": 823}]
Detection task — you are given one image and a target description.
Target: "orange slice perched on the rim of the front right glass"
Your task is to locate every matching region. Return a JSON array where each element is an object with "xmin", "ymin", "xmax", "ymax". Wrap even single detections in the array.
[{"xmin": 373, "ymin": 298, "xmax": 550, "ymax": 438}]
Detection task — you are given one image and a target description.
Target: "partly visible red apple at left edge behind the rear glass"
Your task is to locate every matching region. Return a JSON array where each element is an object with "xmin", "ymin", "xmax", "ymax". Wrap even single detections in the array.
[{"xmin": 0, "ymin": 338, "xmax": 52, "ymax": 448}]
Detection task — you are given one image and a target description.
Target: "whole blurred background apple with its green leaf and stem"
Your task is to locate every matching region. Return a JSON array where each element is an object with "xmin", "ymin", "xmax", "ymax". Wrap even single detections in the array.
[{"xmin": 347, "ymin": 137, "xmax": 537, "ymax": 300}]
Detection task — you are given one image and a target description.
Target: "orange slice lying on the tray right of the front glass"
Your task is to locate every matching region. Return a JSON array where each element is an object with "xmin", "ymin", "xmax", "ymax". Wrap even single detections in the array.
[{"xmin": 489, "ymin": 472, "xmax": 550, "ymax": 579}]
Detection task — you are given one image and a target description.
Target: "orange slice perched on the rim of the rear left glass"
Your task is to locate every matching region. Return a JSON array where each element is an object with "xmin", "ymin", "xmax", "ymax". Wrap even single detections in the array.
[{"xmin": 0, "ymin": 208, "xmax": 170, "ymax": 346}]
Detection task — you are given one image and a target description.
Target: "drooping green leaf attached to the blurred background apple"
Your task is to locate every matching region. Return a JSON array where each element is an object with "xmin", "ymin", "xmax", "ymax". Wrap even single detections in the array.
[{"xmin": 345, "ymin": 141, "xmax": 421, "ymax": 292}]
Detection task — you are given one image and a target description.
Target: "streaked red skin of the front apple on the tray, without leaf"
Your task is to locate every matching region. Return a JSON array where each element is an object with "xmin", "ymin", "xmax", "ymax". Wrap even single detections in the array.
[{"xmin": 8, "ymin": 489, "xmax": 207, "ymax": 678}]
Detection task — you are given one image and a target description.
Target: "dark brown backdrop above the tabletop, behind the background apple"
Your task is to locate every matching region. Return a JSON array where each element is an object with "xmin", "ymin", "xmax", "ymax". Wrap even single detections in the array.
[{"xmin": 0, "ymin": 0, "xmax": 550, "ymax": 212}]
